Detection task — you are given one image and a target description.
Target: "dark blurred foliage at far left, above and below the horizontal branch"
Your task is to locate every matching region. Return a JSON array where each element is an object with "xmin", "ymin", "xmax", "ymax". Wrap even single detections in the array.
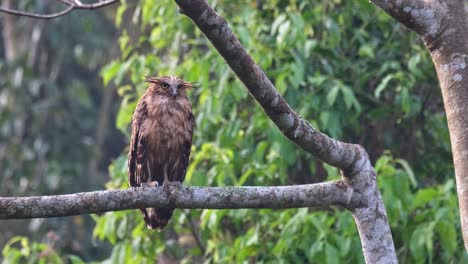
[{"xmin": 0, "ymin": 4, "xmax": 119, "ymax": 254}]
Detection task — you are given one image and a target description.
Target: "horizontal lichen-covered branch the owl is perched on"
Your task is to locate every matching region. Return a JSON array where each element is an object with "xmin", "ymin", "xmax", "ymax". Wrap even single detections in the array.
[{"xmin": 0, "ymin": 181, "xmax": 364, "ymax": 219}]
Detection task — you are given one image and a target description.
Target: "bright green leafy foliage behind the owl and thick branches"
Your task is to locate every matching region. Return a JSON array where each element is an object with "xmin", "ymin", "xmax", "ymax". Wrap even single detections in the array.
[{"xmin": 0, "ymin": 0, "xmax": 468, "ymax": 263}]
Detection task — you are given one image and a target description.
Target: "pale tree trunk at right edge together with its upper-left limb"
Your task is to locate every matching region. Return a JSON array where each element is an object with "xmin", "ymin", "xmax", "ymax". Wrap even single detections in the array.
[{"xmin": 373, "ymin": 0, "xmax": 468, "ymax": 251}]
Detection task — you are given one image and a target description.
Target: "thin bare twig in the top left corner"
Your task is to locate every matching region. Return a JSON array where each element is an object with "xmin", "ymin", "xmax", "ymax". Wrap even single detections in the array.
[{"xmin": 0, "ymin": 0, "xmax": 120, "ymax": 19}]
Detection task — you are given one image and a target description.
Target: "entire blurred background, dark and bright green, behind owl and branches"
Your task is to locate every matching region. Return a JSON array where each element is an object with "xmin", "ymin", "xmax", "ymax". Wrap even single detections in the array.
[{"xmin": 0, "ymin": 0, "xmax": 468, "ymax": 263}]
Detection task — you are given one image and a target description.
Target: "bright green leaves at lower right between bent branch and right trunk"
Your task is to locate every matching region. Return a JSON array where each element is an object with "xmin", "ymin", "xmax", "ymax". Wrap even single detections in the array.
[{"xmin": 375, "ymin": 155, "xmax": 468, "ymax": 263}]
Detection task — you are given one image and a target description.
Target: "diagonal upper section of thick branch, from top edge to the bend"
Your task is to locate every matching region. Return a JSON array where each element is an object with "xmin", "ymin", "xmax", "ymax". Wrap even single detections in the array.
[{"xmin": 175, "ymin": 0, "xmax": 367, "ymax": 175}]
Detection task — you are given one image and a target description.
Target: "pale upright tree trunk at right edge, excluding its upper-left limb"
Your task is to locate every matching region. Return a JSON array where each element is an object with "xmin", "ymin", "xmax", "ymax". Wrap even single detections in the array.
[{"xmin": 424, "ymin": 1, "xmax": 468, "ymax": 251}]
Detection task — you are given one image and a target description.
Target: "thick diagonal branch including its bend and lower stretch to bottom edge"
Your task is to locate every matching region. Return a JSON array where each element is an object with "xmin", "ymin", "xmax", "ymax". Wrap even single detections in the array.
[{"xmin": 175, "ymin": 0, "xmax": 398, "ymax": 263}]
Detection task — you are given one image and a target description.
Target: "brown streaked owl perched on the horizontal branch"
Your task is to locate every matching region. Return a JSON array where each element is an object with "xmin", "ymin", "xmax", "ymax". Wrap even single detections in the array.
[{"xmin": 128, "ymin": 76, "xmax": 195, "ymax": 230}]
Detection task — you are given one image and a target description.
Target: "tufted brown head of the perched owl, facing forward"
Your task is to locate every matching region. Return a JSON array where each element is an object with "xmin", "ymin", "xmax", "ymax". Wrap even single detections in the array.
[{"xmin": 145, "ymin": 76, "xmax": 193, "ymax": 99}]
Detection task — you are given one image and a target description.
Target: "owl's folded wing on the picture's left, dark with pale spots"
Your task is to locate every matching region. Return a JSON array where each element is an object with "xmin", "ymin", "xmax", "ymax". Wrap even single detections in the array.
[{"xmin": 128, "ymin": 100, "xmax": 148, "ymax": 187}]
